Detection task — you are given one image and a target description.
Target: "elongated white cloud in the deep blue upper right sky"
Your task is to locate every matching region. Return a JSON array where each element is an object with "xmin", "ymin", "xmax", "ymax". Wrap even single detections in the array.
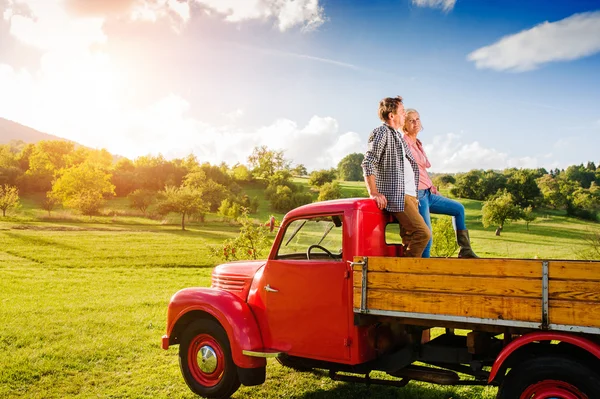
[{"xmin": 467, "ymin": 11, "xmax": 600, "ymax": 72}]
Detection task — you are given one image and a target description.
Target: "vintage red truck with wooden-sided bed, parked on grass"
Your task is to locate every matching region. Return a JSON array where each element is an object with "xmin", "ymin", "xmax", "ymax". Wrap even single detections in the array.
[{"xmin": 162, "ymin": 198, "xmax": 600, "ymax": 399}]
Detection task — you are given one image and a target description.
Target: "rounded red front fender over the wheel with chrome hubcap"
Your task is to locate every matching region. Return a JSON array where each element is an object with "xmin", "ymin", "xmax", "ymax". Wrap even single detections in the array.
[{"xmin": 162, "ymin": 287, "xmax": 266, "ymax": 368}]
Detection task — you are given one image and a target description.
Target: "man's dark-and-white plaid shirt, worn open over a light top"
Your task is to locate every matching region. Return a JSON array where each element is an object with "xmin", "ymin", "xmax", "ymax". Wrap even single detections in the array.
[{"xmin": 362, "ymin": 124, "xmax": 419, "ymax": 212}]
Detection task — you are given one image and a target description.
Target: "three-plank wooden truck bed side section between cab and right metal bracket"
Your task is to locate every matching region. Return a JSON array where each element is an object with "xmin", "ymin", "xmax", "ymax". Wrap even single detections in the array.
[{"xmin": 353, "ymin": 257, "xmax": 542, "ymax": 323}]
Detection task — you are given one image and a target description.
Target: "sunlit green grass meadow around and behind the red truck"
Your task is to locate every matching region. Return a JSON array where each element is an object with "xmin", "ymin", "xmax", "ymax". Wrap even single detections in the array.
[{"xmin": 0, "ymin": 182, "xmax": 599, "ymax": 399}]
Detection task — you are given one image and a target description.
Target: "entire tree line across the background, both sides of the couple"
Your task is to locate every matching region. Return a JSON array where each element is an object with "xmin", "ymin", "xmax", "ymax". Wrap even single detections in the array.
[{"xmin": 0, "ymin": 141, "xmax": 600, "ymax": 228}]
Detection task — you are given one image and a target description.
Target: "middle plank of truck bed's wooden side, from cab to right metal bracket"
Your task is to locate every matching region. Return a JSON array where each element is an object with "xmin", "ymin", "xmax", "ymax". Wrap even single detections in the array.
[{"xmin": 353, "ymin": 272, "xmax": 542, "ymax": 300}]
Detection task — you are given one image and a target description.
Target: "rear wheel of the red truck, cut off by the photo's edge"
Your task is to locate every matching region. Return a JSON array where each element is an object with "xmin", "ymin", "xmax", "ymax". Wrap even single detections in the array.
[{"xmin": 497, "ymin": 356, "xmax": 600, "ymax": 399}]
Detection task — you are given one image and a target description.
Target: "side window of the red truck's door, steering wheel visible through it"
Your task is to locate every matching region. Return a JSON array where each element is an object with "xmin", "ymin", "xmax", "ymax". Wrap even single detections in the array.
[{"xmin": 277, "ymin": 215, "xmax": 343, "ymax": 261}]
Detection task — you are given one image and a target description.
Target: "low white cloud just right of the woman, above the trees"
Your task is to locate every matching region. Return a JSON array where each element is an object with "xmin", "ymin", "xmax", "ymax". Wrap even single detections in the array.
[{"xmin": 425, "ymin": 133, "xmax": 539, "ymax": 173}]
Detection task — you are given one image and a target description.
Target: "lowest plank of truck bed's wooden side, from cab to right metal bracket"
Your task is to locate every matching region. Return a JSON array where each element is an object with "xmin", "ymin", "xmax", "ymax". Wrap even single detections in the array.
[{"xmin": 354, "ymin": 288, "xmax": 542, "ymax": 323}]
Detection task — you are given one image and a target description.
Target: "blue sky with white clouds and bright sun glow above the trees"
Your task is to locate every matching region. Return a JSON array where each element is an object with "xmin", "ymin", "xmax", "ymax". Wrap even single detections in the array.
[{"xmin": 0, "ymin": 0, "xmax": 600, "ymax": 172}]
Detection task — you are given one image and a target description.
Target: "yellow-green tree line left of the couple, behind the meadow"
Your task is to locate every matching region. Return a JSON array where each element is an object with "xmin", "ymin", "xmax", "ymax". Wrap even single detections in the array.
[{"xmin": 0, "ymin": 141, "xmax": 362, "ymax": 228}]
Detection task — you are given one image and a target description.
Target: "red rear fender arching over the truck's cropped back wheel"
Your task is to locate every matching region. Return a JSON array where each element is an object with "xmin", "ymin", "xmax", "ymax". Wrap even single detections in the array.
[{"xmin": 488, "ymin": 332, "xmax": 600, "ymax": 383}]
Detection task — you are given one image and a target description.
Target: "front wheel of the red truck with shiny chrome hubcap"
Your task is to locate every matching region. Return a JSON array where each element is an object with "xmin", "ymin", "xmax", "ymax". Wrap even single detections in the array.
[{"xmin": 179, "ymin": 319, "xmax": 240, "ymax": 398}]
